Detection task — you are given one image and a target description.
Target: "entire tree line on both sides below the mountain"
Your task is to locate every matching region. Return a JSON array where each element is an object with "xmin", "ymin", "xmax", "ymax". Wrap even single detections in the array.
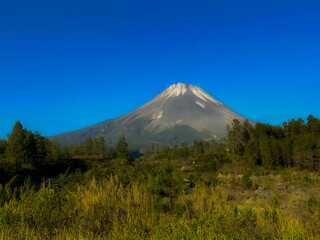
[{"xmin": 0, "ymin": 115, "xmax": 320, "ymax": 182}]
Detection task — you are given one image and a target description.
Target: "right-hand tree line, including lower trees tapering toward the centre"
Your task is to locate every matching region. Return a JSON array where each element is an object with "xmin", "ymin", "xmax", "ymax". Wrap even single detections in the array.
[{"xmin": 145, "ymin": 115, "xmax": 320, "ymax": 171}]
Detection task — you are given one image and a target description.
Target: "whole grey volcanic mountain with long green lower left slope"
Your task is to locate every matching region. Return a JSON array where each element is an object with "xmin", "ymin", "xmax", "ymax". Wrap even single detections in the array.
[{"xmin": 54, "ymin": 83, "xmax": 250, "ymax": 149}]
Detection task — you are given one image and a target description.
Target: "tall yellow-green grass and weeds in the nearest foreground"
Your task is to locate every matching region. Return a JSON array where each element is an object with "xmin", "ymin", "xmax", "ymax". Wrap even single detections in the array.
[{"xmin": 0, "ymin": 170, "xmax": 320, "ymax": 240}]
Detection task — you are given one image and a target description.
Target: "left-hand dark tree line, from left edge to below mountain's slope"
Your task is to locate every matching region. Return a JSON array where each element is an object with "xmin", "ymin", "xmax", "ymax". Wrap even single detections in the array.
[{"xmin": 0, "ymin": 121, "xmax": 130, "ymax": 182}]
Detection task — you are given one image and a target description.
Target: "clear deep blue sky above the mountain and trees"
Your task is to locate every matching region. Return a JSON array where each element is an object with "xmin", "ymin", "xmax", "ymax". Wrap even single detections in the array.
[{"xmin": 0, "ymin": 0, "xmax": 320, "ymax": 138}]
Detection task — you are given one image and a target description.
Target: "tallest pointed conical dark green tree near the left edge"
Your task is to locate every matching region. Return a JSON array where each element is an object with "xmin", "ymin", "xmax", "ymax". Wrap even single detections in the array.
[{"xmin": 6, "ymin": 121, "xmax": 27, "ymax": 164}]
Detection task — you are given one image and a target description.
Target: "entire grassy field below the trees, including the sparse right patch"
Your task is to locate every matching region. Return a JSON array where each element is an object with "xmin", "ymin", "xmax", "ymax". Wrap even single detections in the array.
[{"xmin": 0, "ymin": 156, "xmax": 320, "ymax": 239}]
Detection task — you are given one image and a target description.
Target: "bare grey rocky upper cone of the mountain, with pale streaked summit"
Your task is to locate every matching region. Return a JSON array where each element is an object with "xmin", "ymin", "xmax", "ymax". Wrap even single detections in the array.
[{"xmin": 116, "ymin": 83, "xmax": 244, "ymax": 132}]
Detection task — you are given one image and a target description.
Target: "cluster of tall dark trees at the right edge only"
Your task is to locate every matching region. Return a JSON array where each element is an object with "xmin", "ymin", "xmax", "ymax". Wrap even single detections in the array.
[{"xmin": 227, "ymin": 115, "xmax": 320, "ymax": 171}]
